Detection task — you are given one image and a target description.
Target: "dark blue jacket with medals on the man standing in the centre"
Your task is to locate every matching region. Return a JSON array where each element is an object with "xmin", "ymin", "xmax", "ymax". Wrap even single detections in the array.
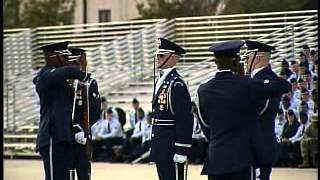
[{"xmin": 150, "ymin": 69, "xmax": 193, "ymax": 162}]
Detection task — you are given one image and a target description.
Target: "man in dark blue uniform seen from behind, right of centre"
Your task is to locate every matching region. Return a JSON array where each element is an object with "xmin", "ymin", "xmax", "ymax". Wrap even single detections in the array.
[{"xmin": 198, "ymin": 41, "xmax": 291, "ymax": 180}]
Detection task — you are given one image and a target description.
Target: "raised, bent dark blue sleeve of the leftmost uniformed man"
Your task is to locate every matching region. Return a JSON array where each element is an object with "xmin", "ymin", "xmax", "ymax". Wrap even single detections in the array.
[{"xmin": 41, "ymin": 66, "xmax": 86, "ymax": 86}]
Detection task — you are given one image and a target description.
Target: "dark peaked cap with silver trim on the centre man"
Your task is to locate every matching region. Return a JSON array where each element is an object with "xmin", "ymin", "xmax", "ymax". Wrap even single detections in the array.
[{"xmin": 156, "ymin": 38, "xmax": 186, "ymax": 56}]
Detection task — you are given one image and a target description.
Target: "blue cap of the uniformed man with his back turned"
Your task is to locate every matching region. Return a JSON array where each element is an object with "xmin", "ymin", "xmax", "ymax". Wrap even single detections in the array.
[{"xmin": 209, "ymin": 40, "xmax": 244, "ymax": 57}]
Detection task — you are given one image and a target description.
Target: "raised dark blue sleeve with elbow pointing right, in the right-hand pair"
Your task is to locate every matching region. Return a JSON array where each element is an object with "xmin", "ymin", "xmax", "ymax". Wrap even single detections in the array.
[{"xmin": 248, "ymin": 77, "xmax": 291, "ymax": 100}]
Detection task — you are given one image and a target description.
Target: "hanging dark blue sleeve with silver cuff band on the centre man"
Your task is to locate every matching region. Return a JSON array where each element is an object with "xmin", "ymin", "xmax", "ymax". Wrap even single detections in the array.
[{"xmin": 171, "ymin": 80, "xmax": 193, "ymax": 155}]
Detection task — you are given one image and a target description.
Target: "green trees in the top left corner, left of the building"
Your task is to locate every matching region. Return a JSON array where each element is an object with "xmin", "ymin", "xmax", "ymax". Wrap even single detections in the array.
[{"xmin": 3, "ymin": 0, "xmax": 75, "ymax": 29}]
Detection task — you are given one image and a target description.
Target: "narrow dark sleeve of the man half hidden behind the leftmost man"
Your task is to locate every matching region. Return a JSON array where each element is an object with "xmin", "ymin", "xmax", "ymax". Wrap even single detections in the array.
[{"xmin": 89, "ymin": 79, "xmax": 101, "ymax": 126}]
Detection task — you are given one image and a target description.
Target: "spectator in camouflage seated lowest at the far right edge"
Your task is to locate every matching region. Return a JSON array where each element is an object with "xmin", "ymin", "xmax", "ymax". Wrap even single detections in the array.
[{"xmin": 298, "ymin": 114, "xmax": 318, "ymax": 168}]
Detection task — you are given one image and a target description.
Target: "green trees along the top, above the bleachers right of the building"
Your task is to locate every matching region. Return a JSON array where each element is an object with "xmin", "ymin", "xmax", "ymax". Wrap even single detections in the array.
[{"xmin": 137, "ymin": 0, "xmax": 318, "ymax": 19}]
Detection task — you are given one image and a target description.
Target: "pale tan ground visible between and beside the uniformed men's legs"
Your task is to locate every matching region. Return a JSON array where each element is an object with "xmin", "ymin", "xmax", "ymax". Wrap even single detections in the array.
[{"xmin": 4, "ymin": 159, "xmax": 318, "ymax": 180}]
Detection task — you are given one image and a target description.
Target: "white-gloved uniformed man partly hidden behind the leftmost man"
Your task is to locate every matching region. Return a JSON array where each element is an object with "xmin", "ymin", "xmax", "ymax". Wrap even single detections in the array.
[{"xmin": 69, "ymin": 48, "xmax": 101, "ymax": 180}]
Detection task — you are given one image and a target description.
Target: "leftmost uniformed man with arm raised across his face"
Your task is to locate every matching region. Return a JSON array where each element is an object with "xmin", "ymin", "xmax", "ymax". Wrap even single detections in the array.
[{"xmin": 34, "ymin": 42, "xmax": 90, "ymax": 180}]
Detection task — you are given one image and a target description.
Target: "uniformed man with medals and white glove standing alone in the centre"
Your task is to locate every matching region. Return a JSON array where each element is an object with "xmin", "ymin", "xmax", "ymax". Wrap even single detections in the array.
[{"xmin": 150, "ymin": 38, "xmax": 193, "ymax": 180}]
